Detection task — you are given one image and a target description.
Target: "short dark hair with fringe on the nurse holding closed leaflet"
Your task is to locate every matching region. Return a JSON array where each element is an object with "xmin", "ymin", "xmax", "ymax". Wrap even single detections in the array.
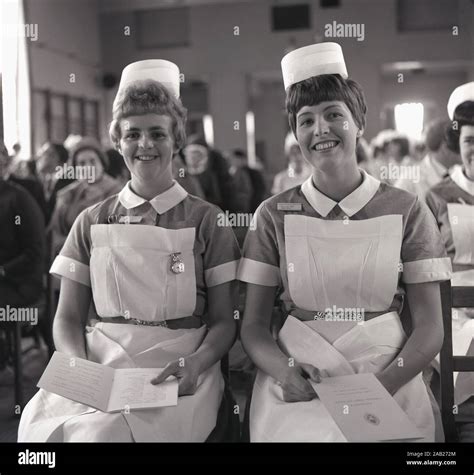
[{"xmin": 286, "ymin": 74, "xmax": 367, "ymax": 136}]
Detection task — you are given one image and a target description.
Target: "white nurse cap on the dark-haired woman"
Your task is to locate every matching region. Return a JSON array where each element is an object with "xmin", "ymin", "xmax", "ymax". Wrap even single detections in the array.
[{"xmin": 281, "ymin": 43, "xmax": 347, "ymax": 90}]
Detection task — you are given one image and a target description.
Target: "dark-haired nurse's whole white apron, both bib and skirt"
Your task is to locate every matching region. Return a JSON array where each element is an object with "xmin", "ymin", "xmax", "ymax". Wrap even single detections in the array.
[{"xmin": 250, "ymin": 215, "xmax": 435, "ymax": 442}]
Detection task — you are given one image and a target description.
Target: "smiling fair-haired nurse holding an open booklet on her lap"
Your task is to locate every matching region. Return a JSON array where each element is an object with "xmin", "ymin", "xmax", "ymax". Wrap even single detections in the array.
[{"xmin": 18, "ymin": 60, "xmax": 240, "ymax": 442}]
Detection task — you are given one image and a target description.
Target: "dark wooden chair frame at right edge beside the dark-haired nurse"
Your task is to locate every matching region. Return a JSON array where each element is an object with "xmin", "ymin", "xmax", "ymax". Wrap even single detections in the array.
[{"xmin": 440, "ymin": 281, "xmax": 474, "ymax": 442}]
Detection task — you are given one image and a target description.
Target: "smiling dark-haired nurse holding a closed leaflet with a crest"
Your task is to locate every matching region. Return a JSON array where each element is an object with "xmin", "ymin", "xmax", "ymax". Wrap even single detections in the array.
[{"xmin": 239, "ymin": 43, "xmax": 451, "ymax": 442}]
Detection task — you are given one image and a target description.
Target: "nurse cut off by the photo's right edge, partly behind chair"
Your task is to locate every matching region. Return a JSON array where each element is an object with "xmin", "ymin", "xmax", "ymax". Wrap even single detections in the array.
[{"xmin": 426, "ymin": 82, "xmax": 474, "ymax": 442}]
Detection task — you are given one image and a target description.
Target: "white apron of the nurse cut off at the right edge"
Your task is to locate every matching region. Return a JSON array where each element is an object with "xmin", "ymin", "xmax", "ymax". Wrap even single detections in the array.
[{"xmin": 447, "ymin": 203, "xmax": 474, "ymax": 405}]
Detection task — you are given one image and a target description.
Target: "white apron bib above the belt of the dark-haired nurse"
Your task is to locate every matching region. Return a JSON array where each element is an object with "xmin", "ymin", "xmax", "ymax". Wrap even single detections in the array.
[{"xmin": 285, "ymin": 215, "xmax": 402, "ymax": 311}]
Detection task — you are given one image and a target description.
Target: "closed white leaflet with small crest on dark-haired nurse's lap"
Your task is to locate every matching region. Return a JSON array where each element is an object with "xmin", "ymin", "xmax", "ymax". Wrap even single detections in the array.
[{"xmin": 312, "ymin": 373, "xmax": 423, "ymax": 442}]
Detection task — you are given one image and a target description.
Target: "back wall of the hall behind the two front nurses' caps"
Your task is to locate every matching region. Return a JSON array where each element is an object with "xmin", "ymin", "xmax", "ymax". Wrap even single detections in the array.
[{"xmin": 101, "ymin": 0, "xmax": 474, "ymax": 172}]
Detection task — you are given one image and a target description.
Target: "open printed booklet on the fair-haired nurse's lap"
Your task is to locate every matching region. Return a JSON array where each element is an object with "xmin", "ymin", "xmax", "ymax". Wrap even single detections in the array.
[{"xmin": 38, "ymin": 351, "xmax": 178, "ymax": 412}]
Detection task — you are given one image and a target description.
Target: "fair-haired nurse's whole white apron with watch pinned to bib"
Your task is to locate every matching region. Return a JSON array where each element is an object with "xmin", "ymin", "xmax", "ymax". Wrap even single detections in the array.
[{"xmin": 18, "ymin": 224, "xmax": 224, "ymax": 442}]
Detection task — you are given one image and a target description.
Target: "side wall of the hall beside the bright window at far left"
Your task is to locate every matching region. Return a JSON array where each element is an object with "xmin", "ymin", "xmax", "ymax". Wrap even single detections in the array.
[{"xmin": 25, "ymin": 0, "xmax": 105, "ymax": 149}]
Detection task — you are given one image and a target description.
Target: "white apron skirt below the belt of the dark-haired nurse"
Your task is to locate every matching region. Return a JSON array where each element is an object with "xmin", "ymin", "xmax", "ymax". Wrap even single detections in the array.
[{"xmin": 250, "ymin": 312, "xmax": 435, "ymax": 442}]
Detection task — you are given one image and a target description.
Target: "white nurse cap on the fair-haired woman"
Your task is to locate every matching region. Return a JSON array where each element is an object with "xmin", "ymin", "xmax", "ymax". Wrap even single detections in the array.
[{"xmin": 117, "ymin": 59, "xmax": 179, "ymax": 97}]
